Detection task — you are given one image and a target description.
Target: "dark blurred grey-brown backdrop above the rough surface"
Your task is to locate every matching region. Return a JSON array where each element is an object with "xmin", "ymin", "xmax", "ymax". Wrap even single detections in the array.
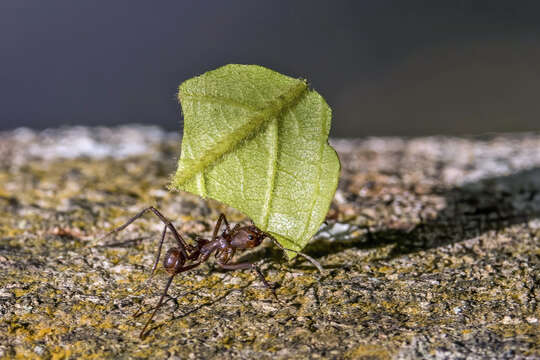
[{"xmin": 0, "ymin": 0, "xmax": 540, "ymax": 136}]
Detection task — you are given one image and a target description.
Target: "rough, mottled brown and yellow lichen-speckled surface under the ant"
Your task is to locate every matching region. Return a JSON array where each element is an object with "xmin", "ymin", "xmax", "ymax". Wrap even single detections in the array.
[{"xmin": 0, "ymin": 127, "xmax": 540, "ymax": 359}]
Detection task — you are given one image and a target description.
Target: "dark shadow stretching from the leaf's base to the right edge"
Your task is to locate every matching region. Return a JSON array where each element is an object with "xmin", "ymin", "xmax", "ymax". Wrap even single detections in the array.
[{"xmin": 305, "ymin": 168, "xmax": 540, "ymax": 258}]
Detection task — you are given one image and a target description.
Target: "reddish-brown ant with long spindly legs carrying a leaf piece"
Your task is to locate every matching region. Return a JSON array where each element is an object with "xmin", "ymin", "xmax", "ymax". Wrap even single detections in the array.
[{"xmin": 103, "ymin": 206, "xmax": 323, "ymax": 339}]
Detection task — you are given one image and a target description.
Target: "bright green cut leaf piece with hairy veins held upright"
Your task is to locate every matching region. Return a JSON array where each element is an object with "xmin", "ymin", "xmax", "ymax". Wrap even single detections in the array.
[{"xmin": 171, "ymin": 64, "xmax": 340, "ymax": 257}]
